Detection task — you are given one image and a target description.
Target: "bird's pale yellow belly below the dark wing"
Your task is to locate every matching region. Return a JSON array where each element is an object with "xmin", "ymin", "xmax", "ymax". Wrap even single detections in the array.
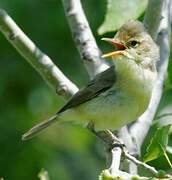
[{"xmin": 72, "ymin": 90, "xmax": 144, "ymax": 130}]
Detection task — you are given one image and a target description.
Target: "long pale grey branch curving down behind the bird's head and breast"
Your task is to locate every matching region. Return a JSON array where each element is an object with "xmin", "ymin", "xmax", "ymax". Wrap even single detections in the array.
[{"xmin": 130, "ymin": 0, "xmax": 171, "ymax": 151}]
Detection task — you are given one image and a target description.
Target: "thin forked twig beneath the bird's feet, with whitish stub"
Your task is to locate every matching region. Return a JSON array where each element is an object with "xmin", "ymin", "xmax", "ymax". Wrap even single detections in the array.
[{"xmin": 88, "ymin": 124, "xmax": 158, "ymax": 177}]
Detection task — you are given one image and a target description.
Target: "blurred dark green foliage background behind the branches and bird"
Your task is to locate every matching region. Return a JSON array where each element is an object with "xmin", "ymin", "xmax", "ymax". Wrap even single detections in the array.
[{"xmin": 0, "ymin": 0, "xmax": 172, "ymax": 180}]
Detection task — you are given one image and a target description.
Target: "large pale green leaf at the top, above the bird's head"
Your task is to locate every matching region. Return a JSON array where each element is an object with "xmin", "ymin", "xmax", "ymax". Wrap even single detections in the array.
[{"xmin": 98, "ymin": 0, "xmax": 147, "ymax": 34}]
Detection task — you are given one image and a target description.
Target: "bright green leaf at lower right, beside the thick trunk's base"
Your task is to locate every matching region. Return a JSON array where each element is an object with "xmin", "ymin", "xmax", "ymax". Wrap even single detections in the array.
[{"xmin": 143, "ymin": 124, "xmax": 171, "ymax": 162}]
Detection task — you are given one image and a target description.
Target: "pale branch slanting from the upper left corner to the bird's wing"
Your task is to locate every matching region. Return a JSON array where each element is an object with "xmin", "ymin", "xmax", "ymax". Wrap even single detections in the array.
[{"xmin": 0, "ymin": 9, "xmax": 78, "ymax": 98}]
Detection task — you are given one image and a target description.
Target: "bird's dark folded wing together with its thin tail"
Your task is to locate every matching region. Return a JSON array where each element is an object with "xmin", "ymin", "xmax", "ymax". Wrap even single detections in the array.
[{"xmin": 22, "ymin": 66, "xmax": 116, "ymax": 140}]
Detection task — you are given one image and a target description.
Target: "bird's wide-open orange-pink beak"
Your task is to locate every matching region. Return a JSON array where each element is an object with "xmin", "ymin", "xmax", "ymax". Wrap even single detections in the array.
[{"xmin": 101, "ymin": 38, "xmax": 126, "ymax": 58}]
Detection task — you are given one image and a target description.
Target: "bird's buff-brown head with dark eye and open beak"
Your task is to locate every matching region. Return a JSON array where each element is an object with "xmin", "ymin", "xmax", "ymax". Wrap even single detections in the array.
[{"xmin": 102, "ymin": 20, "xmax": 159, "ymax": 71}]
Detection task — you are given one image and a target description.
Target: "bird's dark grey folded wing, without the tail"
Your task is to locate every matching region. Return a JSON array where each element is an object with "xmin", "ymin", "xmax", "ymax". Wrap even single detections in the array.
[{"xmin": 58, "ymin": 66, "xmax": 116, "ymax": 114}]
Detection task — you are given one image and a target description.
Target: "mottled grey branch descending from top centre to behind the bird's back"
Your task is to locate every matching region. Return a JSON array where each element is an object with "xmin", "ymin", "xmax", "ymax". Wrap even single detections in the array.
[{"xmin": 62, "ymin": 0, "xmax": 109, "ymax": 78}]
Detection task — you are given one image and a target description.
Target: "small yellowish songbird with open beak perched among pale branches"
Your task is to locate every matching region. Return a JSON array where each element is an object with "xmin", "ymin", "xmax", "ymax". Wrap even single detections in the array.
[{"xmin": 22, "ymin": 20, "xmax": 159, "ymax": 140}]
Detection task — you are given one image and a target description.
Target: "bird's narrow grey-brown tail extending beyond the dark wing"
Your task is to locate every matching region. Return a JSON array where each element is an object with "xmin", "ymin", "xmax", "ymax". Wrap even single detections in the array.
[{"xmin": 22, "ymin": 114, "xmax": 58, "ymax": 141}]
